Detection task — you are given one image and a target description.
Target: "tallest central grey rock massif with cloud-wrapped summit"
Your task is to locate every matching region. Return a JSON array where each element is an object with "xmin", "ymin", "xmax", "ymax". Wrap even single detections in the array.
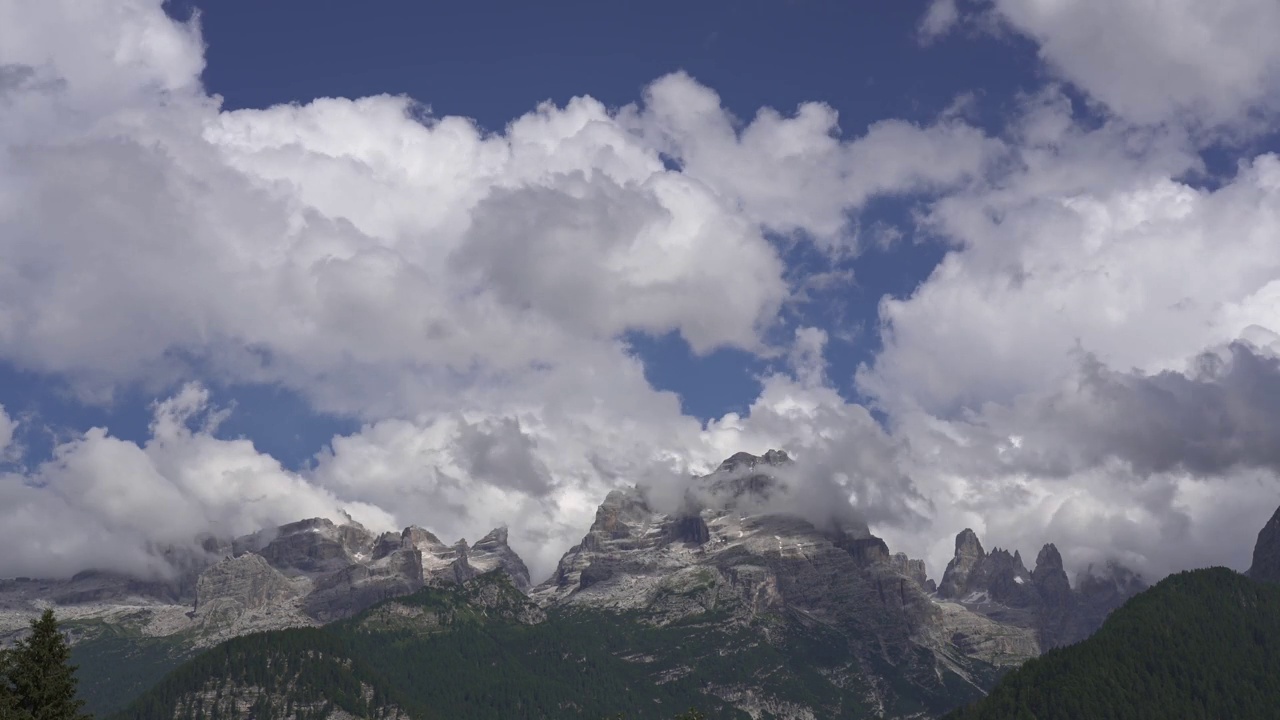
[{"xmin": 532, "ymin": 452, "xmax": 1008, "ymax": 717}]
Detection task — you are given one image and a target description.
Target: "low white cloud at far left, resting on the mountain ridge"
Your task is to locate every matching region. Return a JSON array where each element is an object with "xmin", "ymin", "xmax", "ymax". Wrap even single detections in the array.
[{"xmin": 0, "ymin": 384, "xmax": 394, "ymax": 577}]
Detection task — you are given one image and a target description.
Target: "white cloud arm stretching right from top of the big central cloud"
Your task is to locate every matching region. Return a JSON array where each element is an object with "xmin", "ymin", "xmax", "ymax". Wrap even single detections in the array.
[{"xmin": 622, "ymin": 73, "xmax": 1000, "ymax": 249}]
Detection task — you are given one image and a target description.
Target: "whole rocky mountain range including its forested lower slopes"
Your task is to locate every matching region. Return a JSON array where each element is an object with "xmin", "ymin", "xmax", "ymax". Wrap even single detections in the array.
[{"xmin": 15, "ymin": 451, "xmax": 1280, "ymax": 719}]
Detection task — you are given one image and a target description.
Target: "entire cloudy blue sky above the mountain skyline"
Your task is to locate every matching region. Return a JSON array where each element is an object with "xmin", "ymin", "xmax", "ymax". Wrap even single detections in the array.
[{"xmin": 0, "ymin": 0, "xmax": 1280, "ymax": 579}]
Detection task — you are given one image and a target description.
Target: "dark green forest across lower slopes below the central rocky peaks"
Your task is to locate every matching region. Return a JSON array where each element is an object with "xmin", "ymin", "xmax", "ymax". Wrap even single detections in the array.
[{"xmin": 107, "ymin": 574, "xmax": 977, "ymax": 720}]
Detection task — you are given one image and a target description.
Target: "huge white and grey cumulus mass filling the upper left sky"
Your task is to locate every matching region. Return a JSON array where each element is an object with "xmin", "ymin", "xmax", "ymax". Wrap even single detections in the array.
[{"xmin": 0, "ymin": 0, "xmax": 995, "ymax": 419}]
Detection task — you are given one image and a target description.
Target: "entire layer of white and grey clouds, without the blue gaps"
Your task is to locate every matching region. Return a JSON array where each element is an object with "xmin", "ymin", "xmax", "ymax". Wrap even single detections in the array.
[{"xmin": 0, "ymin": 0, "xmax": 1280, "ymax": 579}]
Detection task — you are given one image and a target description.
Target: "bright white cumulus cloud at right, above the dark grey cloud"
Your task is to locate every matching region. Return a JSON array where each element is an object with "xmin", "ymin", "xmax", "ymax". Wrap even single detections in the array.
[{"xmin": 861, "ymin": 110, "xmax": 1280, "ymax": 416}]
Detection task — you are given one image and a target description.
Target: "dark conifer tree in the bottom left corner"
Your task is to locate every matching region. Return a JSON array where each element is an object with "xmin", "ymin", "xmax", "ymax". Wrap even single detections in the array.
[{"xmin": 9, "ymin": 610, "xmax": 91, "ymax": 720}]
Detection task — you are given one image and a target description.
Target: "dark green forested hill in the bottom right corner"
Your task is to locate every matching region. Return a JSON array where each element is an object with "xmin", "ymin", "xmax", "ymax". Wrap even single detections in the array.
[{"xmin": 947, "ymin": 568, "xmax": 1280, "ymax": 720}]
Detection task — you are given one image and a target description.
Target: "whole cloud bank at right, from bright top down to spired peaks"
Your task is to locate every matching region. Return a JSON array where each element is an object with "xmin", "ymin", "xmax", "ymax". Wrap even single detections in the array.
[{"xmin": 858, "ymin": 90, "xmax": 1280, "ymax": 577}]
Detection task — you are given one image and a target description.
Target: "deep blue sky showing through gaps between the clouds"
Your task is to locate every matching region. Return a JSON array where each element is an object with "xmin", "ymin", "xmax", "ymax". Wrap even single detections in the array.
[{"xmin": 0, "ymin": 0, "xmax": 1042, "ymax": 458}]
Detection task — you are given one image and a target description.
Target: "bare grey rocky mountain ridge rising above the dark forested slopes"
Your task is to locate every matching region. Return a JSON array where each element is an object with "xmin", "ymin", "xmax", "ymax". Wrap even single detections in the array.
[{"xmin": 0, "ymin": 451, "xmax": 1140, "ymax": 717}]
